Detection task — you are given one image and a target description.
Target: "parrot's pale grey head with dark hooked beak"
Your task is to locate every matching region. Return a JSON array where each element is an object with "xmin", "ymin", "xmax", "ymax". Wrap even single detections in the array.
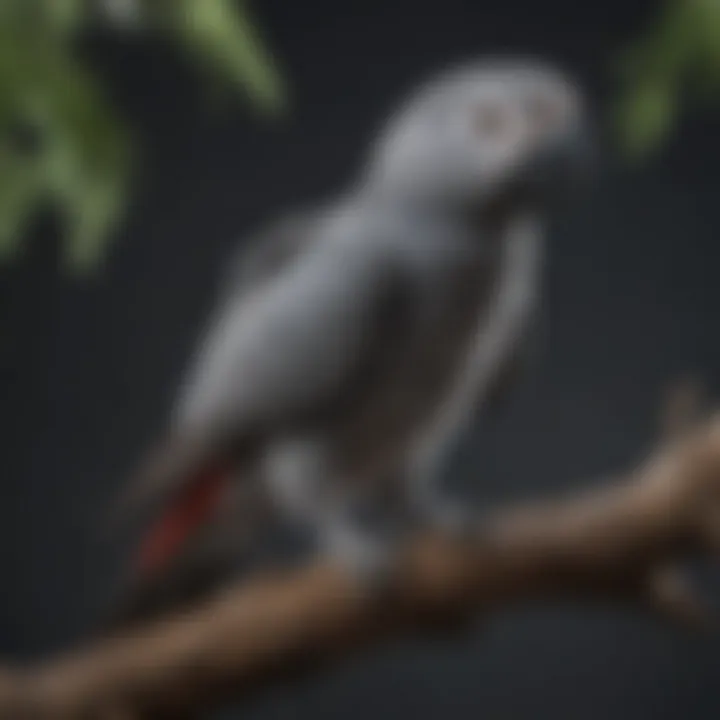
[{"xmin": 369, "ymin": 60, "xmax": 591, "ymax": 214}]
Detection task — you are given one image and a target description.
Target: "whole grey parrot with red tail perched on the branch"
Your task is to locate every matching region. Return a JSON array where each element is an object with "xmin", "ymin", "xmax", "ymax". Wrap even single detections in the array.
[{"xmin": 108, "ymin": 59, "xmax": 589, "ymax": 622}]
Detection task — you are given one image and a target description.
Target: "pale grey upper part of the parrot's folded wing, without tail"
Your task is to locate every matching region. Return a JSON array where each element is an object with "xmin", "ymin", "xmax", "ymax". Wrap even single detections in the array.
[{"xmin": 174, "ymin": 208, "xmax": 410, "ymax": 432}]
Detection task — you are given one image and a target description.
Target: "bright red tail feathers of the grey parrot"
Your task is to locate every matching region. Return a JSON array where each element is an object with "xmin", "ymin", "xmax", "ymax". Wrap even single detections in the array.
[{"xmin": 136, "ymin": 467, "xmax": 228, "ymax": 575}]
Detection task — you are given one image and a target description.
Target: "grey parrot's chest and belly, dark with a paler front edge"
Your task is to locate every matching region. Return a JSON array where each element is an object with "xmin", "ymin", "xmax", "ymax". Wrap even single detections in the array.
[{"xmin": 338, "ymin": 215, "xmax": 538, "ymax": 481}]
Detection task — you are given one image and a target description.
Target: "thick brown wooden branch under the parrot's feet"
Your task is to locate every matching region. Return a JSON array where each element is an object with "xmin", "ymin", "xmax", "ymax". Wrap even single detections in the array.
[{"xmin": 0, "ymin": 408, "xmax": 720, "ymax": 720}]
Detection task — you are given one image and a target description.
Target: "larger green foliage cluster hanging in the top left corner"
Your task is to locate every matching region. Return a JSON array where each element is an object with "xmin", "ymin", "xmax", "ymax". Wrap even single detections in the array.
[{"xmin": 0, "ymin": 0, "xmax": 283, "ymax": 270}]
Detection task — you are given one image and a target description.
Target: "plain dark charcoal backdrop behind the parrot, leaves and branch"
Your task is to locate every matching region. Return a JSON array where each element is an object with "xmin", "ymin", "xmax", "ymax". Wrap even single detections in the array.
[{"xmin": 0, "ymin": 0, "xmax": 720, "ymax": 720}]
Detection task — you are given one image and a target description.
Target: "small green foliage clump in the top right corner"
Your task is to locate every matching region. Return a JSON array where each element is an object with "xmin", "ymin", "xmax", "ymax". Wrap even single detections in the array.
[{"xmin": 616, "ymin": 0, "xmax": 720, "ymax": 157}]
